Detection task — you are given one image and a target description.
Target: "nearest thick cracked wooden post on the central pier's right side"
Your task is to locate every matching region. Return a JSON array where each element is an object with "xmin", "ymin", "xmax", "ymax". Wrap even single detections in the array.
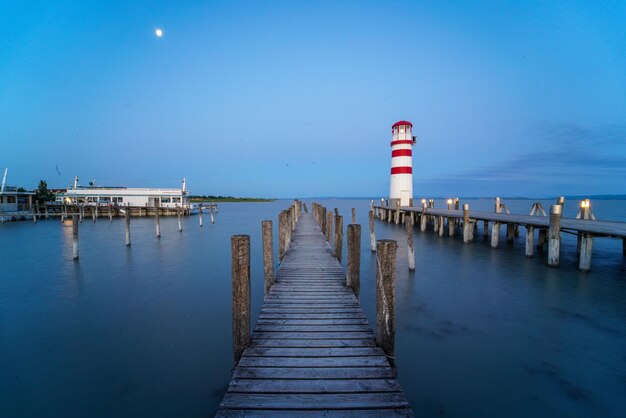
[{"xmin": 376, "ymin": 240, "xmax": 398, "ymax": 369}]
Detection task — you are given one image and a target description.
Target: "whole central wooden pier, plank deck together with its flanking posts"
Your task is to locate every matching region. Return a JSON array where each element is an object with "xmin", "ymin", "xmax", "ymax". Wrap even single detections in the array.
[{"xmin": 216, "ymin": 202, "xmax": 413, "ymax": 417}]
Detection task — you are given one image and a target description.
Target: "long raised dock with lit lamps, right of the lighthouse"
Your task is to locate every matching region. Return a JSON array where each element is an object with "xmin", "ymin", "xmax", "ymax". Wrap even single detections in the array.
[{"xmin": 372, "ymin": 197, "xmax": 626, "ymax": 271}]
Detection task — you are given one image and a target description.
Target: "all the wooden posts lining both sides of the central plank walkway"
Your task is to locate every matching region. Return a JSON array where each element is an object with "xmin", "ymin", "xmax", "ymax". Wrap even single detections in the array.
[{"xmin": 231, "ymin": 200, "xmax": 398, "ymax": 371}]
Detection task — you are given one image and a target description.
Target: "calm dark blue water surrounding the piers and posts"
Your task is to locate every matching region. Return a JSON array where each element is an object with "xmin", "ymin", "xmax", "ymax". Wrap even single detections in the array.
[{"xmin": 0, "ymin": 199, "xmax": 626, "ymax": 417}]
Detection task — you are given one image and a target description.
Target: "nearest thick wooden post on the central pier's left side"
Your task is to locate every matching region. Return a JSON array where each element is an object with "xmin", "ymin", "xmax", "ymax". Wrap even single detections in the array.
[{"xmin": 231, "ymin": 235, "xmax": 250, "ymax": 365}]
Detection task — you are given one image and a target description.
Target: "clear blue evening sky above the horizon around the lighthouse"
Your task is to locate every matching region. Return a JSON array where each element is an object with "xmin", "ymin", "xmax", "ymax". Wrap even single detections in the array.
[{"xmin": 0, "ymin": 0, "xmax": 626, "ymax": 197}]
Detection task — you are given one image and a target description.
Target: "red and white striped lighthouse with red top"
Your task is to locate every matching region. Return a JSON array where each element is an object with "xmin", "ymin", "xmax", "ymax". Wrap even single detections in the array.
[{"xmin": 389, "ymin": 120, "xmax": 415, "ymax": 206}]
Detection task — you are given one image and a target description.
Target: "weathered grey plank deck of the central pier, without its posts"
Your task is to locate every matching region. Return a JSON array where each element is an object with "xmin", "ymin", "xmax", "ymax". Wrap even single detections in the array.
[{"xmin": 216, "ymin": 213, "xmax": 414, "ymax": 417}]
